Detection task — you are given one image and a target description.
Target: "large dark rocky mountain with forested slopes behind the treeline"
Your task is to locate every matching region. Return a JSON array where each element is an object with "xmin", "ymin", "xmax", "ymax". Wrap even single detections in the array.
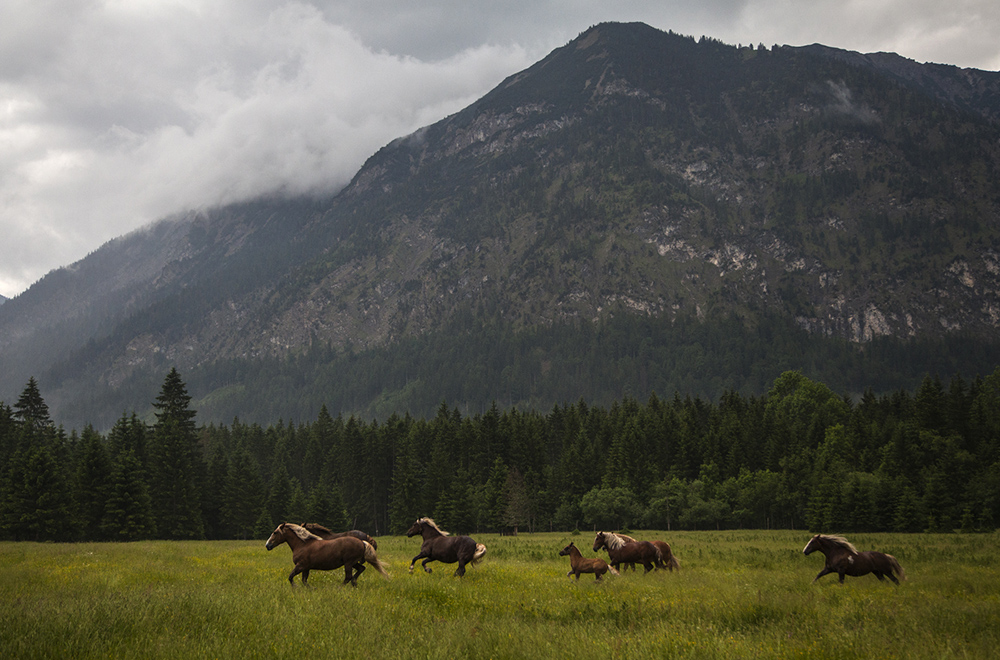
[{"xmin": 0, "ymin": 24, "xmax": 1000, "ymax": 426}]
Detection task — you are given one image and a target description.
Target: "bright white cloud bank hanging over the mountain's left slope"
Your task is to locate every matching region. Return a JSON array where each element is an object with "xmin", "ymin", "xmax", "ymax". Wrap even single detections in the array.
[{"xmin": 0, "ymin": 2, "xmax": 538, "ymax": 295}]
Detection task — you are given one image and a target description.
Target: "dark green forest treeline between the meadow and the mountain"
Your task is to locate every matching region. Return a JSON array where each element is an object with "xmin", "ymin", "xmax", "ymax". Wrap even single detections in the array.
[{"xmin": 0, "ymin": 368, "xmax": 1000, "ymax": 541}]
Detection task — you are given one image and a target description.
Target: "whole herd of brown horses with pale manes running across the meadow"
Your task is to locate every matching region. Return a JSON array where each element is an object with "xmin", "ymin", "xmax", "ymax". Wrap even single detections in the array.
[{"xmin": 264, "ymin": 518, "xmax": 906, "ymax": 587}]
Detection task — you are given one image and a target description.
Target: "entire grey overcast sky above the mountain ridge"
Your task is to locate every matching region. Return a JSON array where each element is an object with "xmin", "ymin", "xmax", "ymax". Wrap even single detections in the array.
[{"xmin": 0, "ymin": 0, "xmax": 1000, "ymax": 297}]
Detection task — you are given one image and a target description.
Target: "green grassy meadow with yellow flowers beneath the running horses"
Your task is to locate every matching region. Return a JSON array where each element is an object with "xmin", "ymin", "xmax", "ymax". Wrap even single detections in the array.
[{"xmin": 0, "ymin": 531, "xmax": 1000, "ymax": 660}]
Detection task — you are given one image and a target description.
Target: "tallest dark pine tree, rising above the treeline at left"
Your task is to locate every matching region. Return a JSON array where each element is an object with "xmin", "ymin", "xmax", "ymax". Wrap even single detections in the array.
[{"xmin": 149, "ymin": 369, "xmax": 205, "ymax": 539}]
